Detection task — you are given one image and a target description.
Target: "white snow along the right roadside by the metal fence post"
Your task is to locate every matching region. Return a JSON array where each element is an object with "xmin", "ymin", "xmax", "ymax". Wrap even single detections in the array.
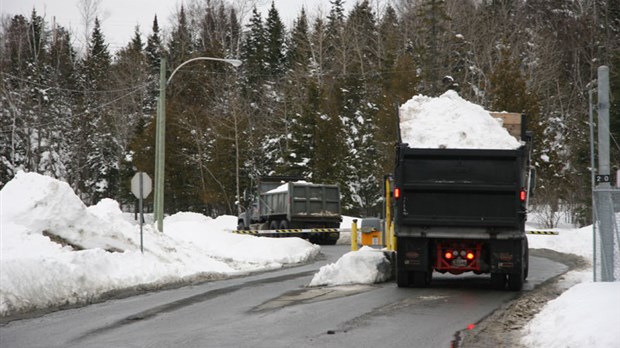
[{"xmin": 521, "ymin": 222, "xmax": 620, "ymax": 348}]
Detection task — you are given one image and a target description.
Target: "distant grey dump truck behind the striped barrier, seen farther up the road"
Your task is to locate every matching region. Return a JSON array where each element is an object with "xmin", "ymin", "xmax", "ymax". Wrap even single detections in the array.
[{"xmin": 237, "ymin": 176, "xmax": 342, "ymax": 245}]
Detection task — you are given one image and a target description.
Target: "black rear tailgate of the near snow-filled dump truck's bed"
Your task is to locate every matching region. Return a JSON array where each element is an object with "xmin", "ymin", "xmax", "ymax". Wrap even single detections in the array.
[{"xmin": 395, "ymin": 146, "xmax": 527, "ymax": 229}]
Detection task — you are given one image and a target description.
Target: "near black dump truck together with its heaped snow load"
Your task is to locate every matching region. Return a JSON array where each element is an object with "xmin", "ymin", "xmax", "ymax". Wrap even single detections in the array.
[{"xmin": 394, "ymin": 91, "xmax": 533, "ymax": 290}]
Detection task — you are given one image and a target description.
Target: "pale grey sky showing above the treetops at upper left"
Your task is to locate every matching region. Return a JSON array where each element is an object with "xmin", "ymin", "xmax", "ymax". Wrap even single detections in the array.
[{"xmin": 0, "ymin": 0, "xmax": 355, "ymax": 51}]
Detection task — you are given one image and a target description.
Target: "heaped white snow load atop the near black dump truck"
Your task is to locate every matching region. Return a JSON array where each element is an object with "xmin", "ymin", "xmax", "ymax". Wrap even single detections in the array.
[{"xmin": 400, "ymin": 91, "xmax": 521, "ymax": 149}]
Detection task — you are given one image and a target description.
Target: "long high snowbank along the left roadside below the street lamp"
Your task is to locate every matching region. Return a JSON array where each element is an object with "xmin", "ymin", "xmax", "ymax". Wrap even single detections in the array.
[{"xmin": 0, "ymin": 172, "xmax": 320, "ymax": 316}]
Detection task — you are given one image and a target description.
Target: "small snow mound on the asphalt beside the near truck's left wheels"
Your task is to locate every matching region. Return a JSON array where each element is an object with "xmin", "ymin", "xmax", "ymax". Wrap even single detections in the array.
[{"xmin": 309, "ymin": 246, "xmax": 390, "ymax": 286}]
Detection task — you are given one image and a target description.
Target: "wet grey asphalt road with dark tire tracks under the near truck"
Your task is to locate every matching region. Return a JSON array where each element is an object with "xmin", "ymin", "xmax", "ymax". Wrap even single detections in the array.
[{"xmin": 0, "ymin": 245, "xmax": 567, "ymax": 348}]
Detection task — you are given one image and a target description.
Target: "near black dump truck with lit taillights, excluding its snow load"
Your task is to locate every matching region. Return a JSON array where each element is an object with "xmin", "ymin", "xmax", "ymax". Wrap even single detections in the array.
[{"xmin": 393, "ymin": 113, "xmax": 534, "ymax": 291}]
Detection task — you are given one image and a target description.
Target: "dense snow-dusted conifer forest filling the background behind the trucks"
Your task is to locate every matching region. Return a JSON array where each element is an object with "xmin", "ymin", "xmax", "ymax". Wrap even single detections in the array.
[{"xmin": 0, "ymin": 0, "xmax": 620, "ymax": 224}]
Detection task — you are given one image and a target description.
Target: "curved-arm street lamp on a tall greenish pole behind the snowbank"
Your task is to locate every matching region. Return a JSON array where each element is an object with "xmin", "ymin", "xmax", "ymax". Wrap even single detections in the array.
[{"xmin": 153, "ymin": 57, "xmax": 241, "ymax": 232}]
